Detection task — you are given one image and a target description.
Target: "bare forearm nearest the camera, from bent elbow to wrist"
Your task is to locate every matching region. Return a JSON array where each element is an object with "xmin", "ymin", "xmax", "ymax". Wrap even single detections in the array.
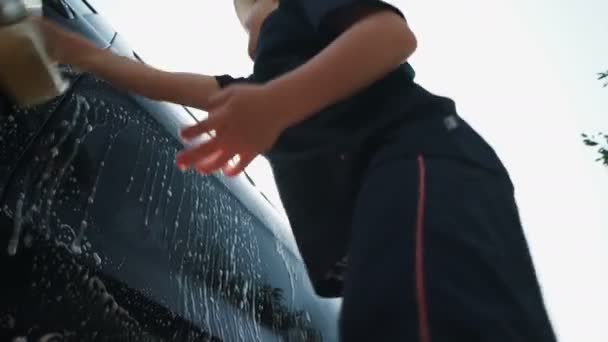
[{"xmin": 267, "ymin": 11, "xmax": 416, "ymax": 126}]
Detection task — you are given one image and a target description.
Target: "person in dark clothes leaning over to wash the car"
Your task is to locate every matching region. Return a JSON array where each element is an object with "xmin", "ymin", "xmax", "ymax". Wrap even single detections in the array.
[{"xmin": 41, "ymin": 0, "xmax": 555, "ymax": 342}]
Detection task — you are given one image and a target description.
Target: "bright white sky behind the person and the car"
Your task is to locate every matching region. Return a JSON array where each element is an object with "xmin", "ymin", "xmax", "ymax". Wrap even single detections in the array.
[{"xmin": 91, "ymin": 0, "xmax": 608, "ymax": 342}]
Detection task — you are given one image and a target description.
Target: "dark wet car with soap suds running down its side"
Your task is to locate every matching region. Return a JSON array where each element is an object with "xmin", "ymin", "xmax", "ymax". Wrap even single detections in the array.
[{"xmin": 0, "ymin": 0, "xmax": 338, "ymax": 342}]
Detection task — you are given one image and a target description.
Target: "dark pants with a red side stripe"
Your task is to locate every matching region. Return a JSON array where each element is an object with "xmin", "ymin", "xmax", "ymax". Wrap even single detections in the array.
[{"xmin": 340, "ymin": 155, "xmax": 556, "ymax": 342}]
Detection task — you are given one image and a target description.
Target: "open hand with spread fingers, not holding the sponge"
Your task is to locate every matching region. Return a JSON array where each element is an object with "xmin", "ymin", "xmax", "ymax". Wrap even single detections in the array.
[{"xmin": 176, "ymin": 85, "xmax": 286, "ymax": 176}]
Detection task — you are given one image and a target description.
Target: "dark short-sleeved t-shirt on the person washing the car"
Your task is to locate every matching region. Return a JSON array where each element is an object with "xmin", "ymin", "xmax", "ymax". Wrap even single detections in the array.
[{"xmin": 217, "ymin": 0, "xmax": 502, "ymax": 296}]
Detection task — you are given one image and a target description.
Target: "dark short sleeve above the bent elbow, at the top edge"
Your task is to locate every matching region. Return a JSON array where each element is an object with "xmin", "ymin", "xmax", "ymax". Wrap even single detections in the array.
[{"xmin": 294, "ymin": 0, "xmax": 405, "ymax": 30}]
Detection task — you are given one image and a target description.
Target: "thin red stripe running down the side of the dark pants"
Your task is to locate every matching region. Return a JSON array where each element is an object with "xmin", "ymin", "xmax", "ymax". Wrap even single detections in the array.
[{"xmin": 415, "ymin": 155, "xmax": 431, "ymax": 342}]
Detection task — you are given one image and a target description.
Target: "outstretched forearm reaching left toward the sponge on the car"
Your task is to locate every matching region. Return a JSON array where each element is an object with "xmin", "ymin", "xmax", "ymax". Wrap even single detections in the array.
[{"xmin": 38, "ymin": 19, "xmax": 220, "ymax": 110}]
